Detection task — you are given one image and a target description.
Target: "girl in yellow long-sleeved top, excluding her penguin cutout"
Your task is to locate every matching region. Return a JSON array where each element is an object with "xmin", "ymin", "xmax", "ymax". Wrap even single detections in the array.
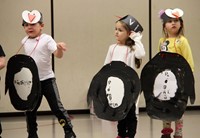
[{"xmin": 159, "ymin": 8, "xmax": 194, "ymax": 138}]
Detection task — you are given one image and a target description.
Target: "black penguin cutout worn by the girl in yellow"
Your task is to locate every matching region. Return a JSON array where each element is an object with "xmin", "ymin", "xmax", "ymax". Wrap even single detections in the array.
[{"xmin": 141, "ymin": 52, "xmax": 195, "ymax": 121}]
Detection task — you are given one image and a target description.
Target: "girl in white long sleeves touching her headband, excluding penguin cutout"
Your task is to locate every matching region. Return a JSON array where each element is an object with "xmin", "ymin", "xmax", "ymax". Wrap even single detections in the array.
[{"xmin": 105, "ymin": 15, "xmax": 145, "ymax": 138}]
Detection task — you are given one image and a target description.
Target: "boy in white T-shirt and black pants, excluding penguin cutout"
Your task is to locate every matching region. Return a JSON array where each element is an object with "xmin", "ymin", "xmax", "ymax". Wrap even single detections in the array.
[{"xmin": 22, "ymin": 10, "xmax": 76, "ymax": 138}]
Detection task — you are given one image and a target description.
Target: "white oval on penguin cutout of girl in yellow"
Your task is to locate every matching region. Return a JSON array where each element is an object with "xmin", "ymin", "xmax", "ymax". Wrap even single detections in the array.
[{"xmin": 153, "ymin": 70, "xmax": 178, "ymax": 101}]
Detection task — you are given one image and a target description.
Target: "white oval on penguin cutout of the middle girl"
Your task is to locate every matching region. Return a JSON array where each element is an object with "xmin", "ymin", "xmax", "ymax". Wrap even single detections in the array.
[{"xmin": 106, "ymin": 77, "xmax": 124, "ymax": 108}]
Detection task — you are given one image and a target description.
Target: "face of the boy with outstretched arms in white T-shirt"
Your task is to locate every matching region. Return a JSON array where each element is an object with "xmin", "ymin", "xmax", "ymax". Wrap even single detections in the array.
[{"xmin": 24, "ymin": 23, "xmax": 44, "ymax": 38}]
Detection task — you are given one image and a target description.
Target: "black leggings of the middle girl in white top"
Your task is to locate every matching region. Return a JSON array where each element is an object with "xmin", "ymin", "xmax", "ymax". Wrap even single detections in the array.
[{"xmin": 117, "ymin": 104, "xmax": 137, "ymax": 138}]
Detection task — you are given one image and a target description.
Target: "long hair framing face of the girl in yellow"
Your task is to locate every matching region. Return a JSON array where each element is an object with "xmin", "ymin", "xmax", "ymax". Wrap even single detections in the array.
[{"xmin": 162, "ymin": 17, "xmax": 184, "ymax": 38}]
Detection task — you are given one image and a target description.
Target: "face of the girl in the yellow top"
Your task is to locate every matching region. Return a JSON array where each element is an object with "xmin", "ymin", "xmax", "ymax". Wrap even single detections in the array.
[{"xmin": 164, "ymin": 19, "xmax": 181, "ymax": 37}]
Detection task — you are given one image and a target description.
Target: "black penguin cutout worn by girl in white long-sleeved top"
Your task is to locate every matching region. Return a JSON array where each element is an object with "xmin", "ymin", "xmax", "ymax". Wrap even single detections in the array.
[{"xmin": 87, "ymin": 61, "xmax": 141, "ymax": 121}]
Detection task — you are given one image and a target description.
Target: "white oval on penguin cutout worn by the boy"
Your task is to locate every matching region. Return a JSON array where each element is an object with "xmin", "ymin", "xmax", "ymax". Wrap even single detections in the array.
[{"xmin": 13, "ymin": 68, "xmax": 33, "ymax": 100}]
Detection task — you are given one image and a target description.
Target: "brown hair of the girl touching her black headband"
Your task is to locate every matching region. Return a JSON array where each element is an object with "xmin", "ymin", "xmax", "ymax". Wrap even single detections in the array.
[{"xmin": 118, "ymin": 21, "xmax": 142, "ymax": 68}]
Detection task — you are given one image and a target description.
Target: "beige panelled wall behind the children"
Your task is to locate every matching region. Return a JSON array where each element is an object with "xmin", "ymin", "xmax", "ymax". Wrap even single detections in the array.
[{"xmin": 0, "ymin": 0, "xmax": 200, "ymax": 112}]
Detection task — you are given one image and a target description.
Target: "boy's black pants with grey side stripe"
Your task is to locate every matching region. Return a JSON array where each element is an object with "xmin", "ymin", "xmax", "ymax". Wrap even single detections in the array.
[{"xmin": 26, "ymin": 78, "xmax": 72, "ymax": 133}]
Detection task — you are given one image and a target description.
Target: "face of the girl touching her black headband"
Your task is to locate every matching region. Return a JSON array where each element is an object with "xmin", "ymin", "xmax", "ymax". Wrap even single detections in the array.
[{"xmin": 115, "ymin": 21, "xmax": 130, "ymax": 45}]
